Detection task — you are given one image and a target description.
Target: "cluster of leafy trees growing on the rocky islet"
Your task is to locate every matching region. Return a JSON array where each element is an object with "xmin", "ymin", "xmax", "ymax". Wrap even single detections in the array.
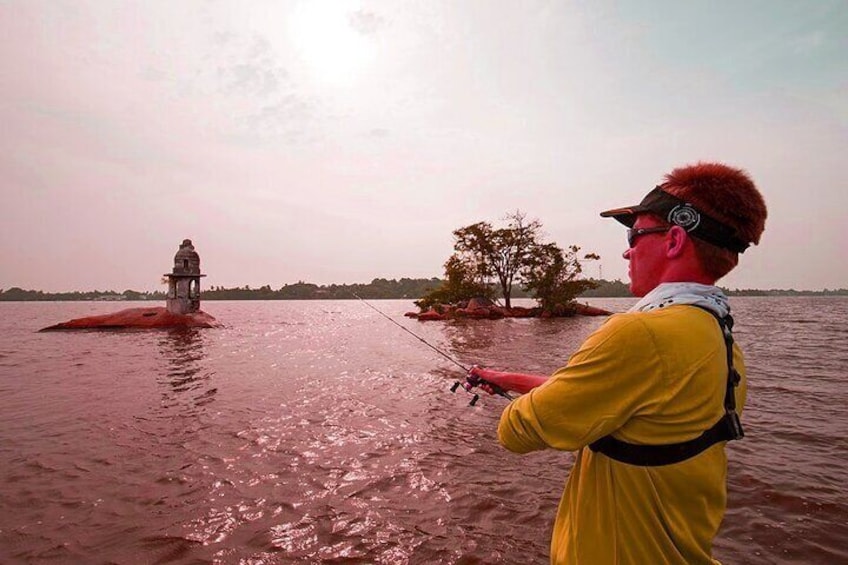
[{"xmin": 415, "ymin": 211, "xmax": 600, "ymax": 315}]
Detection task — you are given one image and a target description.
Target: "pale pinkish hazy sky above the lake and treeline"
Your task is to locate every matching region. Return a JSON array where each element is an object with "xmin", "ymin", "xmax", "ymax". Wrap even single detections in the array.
[{"xmin": 0, "ymin": 0, "xmax": 848, "ymax": 292}]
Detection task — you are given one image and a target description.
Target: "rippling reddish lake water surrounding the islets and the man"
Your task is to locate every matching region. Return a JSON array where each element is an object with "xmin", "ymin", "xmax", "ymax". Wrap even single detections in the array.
[{"xmin": 0, "ymin": 297, "xmax": 848, "ymax": 565}]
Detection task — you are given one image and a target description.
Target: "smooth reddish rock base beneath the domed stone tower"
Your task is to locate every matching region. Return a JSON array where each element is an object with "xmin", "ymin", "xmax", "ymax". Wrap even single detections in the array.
[{"xmin": 39, "ymin": 306, "xmax": 220, "ymax": 332}]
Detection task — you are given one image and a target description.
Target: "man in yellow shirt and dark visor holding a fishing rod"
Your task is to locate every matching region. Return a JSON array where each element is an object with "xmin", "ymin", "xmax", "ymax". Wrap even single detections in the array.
[{"xmin": 468, "ymin": 163, "xmax": 766, "ymax": 565}]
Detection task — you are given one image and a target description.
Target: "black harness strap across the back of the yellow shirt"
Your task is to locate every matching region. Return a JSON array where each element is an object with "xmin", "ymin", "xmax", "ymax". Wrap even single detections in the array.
[{"xmin": 589, "ymin": 306, "xmax": 745, "ymax": 467}]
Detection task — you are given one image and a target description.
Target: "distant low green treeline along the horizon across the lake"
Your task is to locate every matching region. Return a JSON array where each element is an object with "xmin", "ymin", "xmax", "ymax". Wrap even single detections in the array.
[{"xmin": 0, "ymin": 277, "xmax": 848, "ymax": 302}]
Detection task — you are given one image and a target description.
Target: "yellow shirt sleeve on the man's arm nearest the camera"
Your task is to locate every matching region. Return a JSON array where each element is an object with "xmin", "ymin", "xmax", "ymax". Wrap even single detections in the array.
[{"xmin": 498, "ymin": 314, "xmax": 666, "ymax": 453}]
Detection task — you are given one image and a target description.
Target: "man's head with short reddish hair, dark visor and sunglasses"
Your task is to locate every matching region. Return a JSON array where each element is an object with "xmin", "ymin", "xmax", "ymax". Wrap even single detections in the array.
[{"xmin": 601, "ymin": 163, "xmax": 767, "ymax": 295}]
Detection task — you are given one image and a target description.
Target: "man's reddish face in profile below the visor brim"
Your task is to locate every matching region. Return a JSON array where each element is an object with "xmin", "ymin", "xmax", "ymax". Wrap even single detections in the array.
[{"xmin": 624, "ymin": 214, "xmax": 666, "ymax": 296}]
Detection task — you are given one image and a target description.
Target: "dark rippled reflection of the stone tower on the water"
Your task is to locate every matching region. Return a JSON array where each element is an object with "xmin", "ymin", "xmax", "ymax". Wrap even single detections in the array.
[{"xmin": 159, "ymin": 328, "xmax": 218, "ymax": 407}]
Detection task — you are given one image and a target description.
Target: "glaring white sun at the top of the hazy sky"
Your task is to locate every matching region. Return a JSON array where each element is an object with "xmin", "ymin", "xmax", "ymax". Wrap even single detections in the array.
[{"xmin": 289, "ymin": 0, "xmax": 376, "ymax": 86}]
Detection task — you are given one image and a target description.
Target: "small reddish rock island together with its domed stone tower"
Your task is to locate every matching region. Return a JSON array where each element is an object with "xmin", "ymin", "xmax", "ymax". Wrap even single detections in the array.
[{"xmin": 39, "ymin": 239, "xmax": 219, "ymax": 331}]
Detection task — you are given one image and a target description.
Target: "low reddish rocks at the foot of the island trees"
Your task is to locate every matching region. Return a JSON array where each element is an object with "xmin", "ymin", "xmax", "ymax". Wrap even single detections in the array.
[{"xmin": 405, "ymin": 298, "xmax": 612, "ymax": 322}]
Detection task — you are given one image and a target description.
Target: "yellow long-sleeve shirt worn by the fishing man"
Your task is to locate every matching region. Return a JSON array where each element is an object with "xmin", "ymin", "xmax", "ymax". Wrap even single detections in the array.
[{"xmin": 498, "ymin": 306, "xmax": 746, "ymax": 565}]
